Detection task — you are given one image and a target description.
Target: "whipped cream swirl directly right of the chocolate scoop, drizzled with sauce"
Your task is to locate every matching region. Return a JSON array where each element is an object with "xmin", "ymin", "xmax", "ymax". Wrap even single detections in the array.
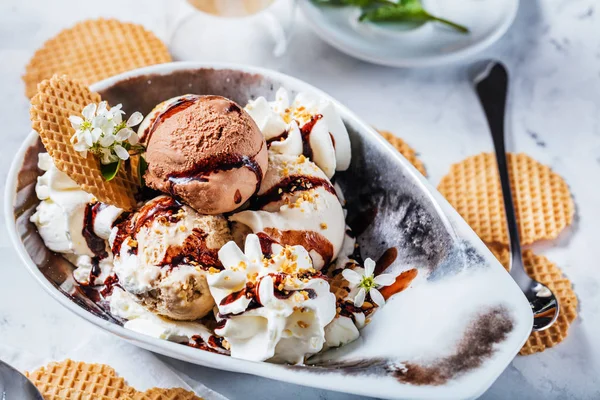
[{"xmin": 244, "ymin": 88, "xmax": 352, "ymax": 178}]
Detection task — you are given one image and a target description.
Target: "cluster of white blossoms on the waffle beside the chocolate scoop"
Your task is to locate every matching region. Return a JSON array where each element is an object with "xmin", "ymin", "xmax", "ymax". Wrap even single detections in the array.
[{"xmin": 69, "ymin": 101, "xmax": 144, "ymax": 165}]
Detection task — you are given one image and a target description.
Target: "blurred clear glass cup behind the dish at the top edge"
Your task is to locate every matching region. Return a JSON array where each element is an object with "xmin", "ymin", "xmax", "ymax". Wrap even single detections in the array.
[{"xmin": 165, "ymin": 0, "xmax": 296, "ymax": 68}]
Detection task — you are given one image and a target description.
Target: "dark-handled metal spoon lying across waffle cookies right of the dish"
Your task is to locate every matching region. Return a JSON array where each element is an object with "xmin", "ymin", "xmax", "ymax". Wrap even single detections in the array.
[{"xmin": 474, "ymin": 61, "xmax": 559, "ymax": 331}]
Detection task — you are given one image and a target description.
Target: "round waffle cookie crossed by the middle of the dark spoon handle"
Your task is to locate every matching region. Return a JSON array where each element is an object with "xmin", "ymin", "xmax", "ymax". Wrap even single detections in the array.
[{"xmin": 438, "ymin": 153, "xmax": 575, "ymax": 245}]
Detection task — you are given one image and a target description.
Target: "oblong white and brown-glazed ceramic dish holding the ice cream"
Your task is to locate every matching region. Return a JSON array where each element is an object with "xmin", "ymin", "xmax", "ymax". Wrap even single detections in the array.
[{"xmin": 5, "ymin": 63, "xmax": 532, "ymax": 399}]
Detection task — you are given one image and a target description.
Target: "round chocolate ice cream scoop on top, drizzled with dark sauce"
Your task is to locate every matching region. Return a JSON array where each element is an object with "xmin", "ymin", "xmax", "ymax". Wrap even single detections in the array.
[{"xmin": 139, "ymin": 95, "xmax": 268, "ymax": 214}]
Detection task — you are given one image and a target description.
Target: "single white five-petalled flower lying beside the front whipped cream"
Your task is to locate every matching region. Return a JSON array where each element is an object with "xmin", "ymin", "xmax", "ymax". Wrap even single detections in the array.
[{"xmin": 342, "ymin": 258, "xmax": 396, "ymax": 307}]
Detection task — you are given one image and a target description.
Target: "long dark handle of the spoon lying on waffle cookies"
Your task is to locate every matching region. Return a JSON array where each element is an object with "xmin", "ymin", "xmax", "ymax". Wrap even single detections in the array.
[{"xmin": 475, "ymin": 61, "xmax": 532, "ymax": 291}]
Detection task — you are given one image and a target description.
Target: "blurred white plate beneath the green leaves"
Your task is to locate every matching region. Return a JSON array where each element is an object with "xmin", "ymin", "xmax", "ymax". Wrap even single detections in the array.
[{"xmin": 300, "ymin": 0, "xmax": 519, "ymax": 67}]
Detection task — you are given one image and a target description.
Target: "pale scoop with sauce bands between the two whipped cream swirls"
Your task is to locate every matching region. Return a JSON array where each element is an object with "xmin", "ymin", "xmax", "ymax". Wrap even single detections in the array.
[{"xmin": 229, "ymin": 152, "xmax": 346, "ymax": 269}]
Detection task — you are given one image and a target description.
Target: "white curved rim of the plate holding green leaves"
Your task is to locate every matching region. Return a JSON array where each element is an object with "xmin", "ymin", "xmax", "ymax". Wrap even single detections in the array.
[{"xmin": 299, "ymin": 0, "xmax": 519, "ymax": 68}]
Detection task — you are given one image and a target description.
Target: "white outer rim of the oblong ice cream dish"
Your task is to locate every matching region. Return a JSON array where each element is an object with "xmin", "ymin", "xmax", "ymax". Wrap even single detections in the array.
[{"xmin": 4, "ymin": 62, "xmax": 529, "ymax": 399}]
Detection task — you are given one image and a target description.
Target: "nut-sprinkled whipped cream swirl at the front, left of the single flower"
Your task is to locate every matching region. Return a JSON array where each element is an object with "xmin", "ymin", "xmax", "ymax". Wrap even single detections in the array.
[{"xmin": 207, "ymin": 234, "xmax": 336, "ymax": 364}]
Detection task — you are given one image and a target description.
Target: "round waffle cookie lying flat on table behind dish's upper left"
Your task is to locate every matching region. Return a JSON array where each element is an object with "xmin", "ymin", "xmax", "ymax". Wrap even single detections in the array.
[{"xmin": 23, "ymin": 19, "xmax": 172, "ymax": 98}]
